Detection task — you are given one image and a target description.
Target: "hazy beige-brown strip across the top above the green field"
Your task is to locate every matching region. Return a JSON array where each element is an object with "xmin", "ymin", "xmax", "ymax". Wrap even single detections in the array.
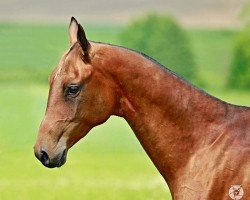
[{"xmin": 0, "ymin": 0, "xmax": 249, "ymax": 27}]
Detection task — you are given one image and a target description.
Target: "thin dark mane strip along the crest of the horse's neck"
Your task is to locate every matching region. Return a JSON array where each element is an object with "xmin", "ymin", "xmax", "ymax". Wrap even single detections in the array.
[{"xmin": 91, "ymin": 41, "xmax": 249, "ymax": 108}]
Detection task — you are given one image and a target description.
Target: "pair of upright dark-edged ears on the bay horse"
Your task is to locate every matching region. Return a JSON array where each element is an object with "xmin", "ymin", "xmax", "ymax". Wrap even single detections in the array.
[{"xmin": 69, "ymin": 17, "xmax": 90, "ymax": 55}]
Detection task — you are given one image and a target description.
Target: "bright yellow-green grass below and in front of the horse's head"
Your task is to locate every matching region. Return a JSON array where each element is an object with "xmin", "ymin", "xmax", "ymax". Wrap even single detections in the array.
[{"xmin": 0, "ymin": 83, "xmax": 170, "ymax": 200}]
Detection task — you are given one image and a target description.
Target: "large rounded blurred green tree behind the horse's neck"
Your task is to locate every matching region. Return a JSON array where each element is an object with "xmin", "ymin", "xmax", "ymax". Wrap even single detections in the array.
[{"xmin": 120, "ymin": 13, "xmax": 196, "ymax": 81}]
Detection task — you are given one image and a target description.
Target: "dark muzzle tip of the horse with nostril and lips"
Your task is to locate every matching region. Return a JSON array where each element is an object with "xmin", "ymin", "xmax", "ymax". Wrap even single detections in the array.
[{"xmin": 35, "ymin": 149, "xmax": 67, "ymax": 168}]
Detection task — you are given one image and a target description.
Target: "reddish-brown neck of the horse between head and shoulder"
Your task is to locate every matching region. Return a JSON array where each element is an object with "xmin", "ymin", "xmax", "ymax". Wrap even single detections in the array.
[{"xmin": 93, "ymin": 42, "xmax": 228, "ymax": 188}]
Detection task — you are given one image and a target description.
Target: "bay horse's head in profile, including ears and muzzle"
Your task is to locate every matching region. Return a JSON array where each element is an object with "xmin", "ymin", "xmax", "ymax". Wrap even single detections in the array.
[{"xmin": 34, "ymin": 18, "xmax": 116, "ymax": 168}]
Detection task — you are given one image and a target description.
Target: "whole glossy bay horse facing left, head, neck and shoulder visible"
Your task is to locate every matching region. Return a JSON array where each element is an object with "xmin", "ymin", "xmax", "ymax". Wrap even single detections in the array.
[{"xmin": 34, "ymin": 17, "xmax": 250, "ymax": 200}]
